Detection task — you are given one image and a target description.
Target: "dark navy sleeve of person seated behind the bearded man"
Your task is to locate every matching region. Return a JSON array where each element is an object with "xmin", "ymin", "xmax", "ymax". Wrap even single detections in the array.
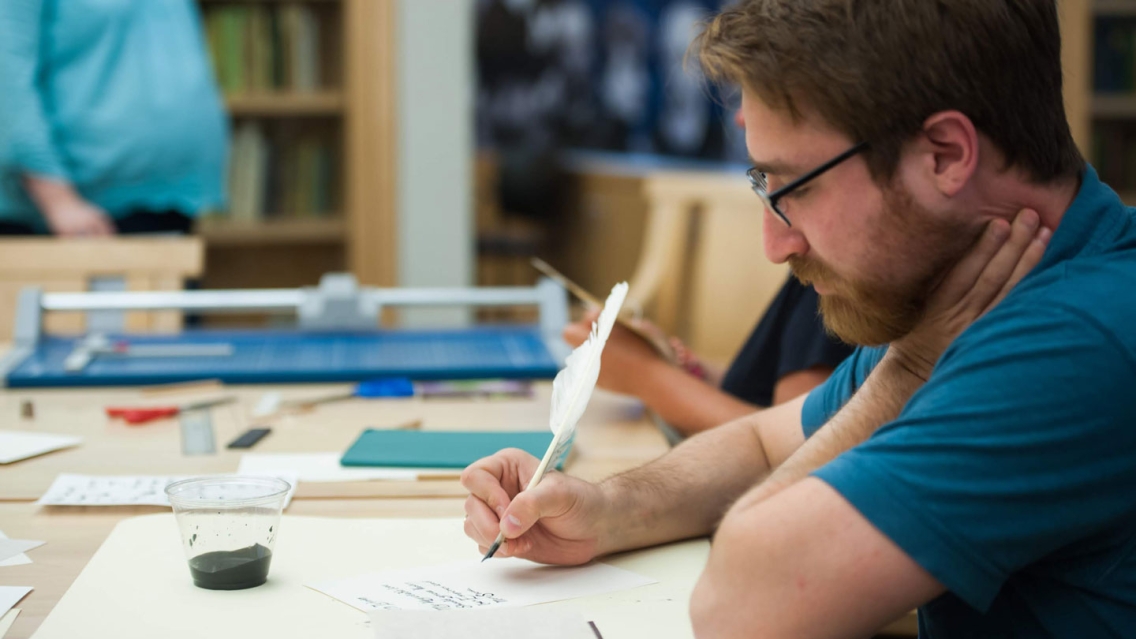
[{"xmin": 777, "ymin": 287, "xmax": 854, "ymax": 380}]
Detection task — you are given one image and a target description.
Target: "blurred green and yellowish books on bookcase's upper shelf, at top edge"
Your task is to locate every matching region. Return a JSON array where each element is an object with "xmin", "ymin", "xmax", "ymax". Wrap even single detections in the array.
[{"xmin": 204, "ymin": 2, "xmax": 323, "ymax": 94}]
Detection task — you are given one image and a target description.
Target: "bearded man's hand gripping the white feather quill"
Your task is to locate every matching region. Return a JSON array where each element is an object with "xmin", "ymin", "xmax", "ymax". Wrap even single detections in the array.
[{"xmin": 461, "ymin": 448, "xmax": 607, "ymax": 565}]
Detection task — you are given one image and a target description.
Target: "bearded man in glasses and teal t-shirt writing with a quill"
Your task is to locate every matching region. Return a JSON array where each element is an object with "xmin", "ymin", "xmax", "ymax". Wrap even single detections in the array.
[{"xmin": 462, "ymin": 0, "xmax": 1136, "ymax": 639}]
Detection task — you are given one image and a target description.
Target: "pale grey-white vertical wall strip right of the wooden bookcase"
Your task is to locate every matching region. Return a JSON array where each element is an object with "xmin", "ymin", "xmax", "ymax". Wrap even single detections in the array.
[{"xmin": 396, "ymin": 0, "xmax": 475, "ymax": 325}]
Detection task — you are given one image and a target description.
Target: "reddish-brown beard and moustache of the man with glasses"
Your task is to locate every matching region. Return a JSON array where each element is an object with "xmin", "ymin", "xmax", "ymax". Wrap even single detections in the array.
[{"xmin": 788, "ymin": 186, "xmax": 975, "ymax": 346}]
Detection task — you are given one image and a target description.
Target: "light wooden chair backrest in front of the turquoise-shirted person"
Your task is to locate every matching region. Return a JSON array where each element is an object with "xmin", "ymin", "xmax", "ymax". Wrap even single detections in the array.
[{"xmin": 0, "ymin": 236, "xmax": 204, "ymax": 341}]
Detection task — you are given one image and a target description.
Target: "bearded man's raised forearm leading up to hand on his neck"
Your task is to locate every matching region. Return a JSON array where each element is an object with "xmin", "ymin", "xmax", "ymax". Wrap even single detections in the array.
[{"xmin": 738, "ymin": 356, "xmax": 924, "ymax": 507}]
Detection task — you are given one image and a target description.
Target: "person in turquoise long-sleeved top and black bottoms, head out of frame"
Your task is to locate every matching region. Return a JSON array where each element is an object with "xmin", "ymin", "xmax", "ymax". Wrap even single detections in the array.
[{"xmin": 0, "ymin": 0, "xmax": 228, "ymax": 235}]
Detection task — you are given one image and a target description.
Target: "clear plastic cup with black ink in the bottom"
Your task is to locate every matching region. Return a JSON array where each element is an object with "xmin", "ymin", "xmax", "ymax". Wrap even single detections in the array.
[{"xmin": 166, "ymin": 476, "xmax": 292, "ymax": 590}]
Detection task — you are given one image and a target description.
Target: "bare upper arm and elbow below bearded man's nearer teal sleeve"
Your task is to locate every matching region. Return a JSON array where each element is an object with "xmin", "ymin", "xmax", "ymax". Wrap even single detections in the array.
[{"xmin": 691, "ymin": 478, "xmax": 944, "ymax": 639}]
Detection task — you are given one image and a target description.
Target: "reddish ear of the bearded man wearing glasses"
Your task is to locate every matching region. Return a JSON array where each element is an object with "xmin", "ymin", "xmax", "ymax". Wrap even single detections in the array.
[{"xmin": 916, "ymin": 111, "xmax": 978, "ymax": 197}]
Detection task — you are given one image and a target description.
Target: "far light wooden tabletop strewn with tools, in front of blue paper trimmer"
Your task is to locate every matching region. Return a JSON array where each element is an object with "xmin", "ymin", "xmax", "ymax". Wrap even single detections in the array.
[{"xmin": 0, "ymin": 382, "xmax": 667, "ymax": 501}]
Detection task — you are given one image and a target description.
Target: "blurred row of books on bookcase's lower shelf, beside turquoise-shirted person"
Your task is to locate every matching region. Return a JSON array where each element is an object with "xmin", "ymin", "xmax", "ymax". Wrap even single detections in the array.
[{"xmin": 228, "ymin": 121, "xmax": 336, "ymax": 223}]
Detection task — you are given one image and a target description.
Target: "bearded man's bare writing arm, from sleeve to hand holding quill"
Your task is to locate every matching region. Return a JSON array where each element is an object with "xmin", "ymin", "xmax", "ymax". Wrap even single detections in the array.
[{"xmin": 461, "ymin": 397, "xmax": 804, "ymax": 564}]
